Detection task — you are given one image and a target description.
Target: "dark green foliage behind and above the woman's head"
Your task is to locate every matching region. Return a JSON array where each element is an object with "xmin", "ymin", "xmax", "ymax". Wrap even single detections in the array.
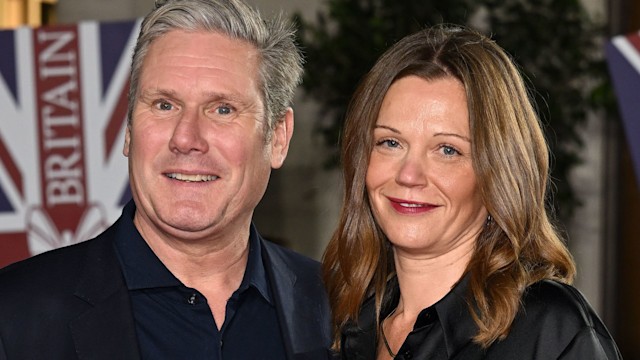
[{"xmin": 296, "ymin": 0, "xmax": 608, "ymax": 219}]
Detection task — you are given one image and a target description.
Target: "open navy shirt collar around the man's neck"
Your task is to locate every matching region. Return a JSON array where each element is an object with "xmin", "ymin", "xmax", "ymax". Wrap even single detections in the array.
[{"xmin": 115, "ymin": 200, "xmax": 273, "ymax": 304}]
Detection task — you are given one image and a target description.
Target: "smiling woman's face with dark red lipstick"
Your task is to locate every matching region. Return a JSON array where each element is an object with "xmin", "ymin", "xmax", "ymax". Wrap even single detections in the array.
[{"xmin": 366, "ymin": 76, "xmax": 487, "ymax": 257}]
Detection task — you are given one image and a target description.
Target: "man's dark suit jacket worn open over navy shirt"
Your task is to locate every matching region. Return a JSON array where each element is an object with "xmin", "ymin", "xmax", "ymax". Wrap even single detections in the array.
[{"xmin": 0, "ymin": 207, "xmax": 330, "ymax": 360}]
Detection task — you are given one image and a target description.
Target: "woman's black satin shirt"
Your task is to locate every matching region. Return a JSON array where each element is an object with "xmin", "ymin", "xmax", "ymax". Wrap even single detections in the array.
[{"xmin": 341, "ymin": 278, "xmax": 622, "ymax": 360}]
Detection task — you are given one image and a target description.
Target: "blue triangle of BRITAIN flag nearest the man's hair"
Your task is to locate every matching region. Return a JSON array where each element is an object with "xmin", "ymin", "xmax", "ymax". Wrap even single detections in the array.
[{"xmin": 100, "ymin": 21, "xmax": 135, "ymax": 94}]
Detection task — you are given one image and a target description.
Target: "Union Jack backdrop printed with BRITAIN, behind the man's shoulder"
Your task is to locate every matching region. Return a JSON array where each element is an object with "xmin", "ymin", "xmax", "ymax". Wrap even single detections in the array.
[{"xmin": 0, "ymin": 21, "xmax": 139, "ymax": 267}]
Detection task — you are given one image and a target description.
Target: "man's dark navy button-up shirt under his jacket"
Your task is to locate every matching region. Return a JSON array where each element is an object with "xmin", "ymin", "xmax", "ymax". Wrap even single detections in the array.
[{"xmin": 115, "ymin": 204, "xmax": 285, "ymax": 359}]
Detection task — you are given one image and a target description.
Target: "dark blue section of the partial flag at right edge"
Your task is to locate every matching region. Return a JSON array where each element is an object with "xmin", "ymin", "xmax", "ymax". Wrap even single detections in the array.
[{"xmin": 605, "ymin": 38, "xmax": 640, "ymax": 185}]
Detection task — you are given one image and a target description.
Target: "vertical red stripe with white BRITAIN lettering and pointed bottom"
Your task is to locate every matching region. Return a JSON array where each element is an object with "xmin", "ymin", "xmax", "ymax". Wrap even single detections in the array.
[{"xmin": 33, "ymin": 25, "xmax": 88, "ymax": 233}]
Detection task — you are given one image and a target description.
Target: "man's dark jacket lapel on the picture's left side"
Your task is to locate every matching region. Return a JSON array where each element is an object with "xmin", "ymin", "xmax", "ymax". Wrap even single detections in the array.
[{"xmin": 70, "ymin": 223, "xmax": 140, "ymax": 360}]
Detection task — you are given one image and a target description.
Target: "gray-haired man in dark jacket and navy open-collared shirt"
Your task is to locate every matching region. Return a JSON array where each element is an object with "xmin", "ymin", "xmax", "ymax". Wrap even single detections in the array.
[{"xmin": 0, "ymin": 0, "xmax": 330, "ymax": 360}]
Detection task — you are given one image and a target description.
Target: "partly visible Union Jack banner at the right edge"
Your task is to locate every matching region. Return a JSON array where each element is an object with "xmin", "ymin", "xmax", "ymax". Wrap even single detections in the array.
[{"xmin": 605, "ymin": 31, "xmax": 640, "ymax": 186}]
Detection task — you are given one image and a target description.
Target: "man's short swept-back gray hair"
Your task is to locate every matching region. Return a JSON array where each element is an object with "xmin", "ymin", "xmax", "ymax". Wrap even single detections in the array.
[{"xmin": 128, "ymin": 0, "xmax": 303, "ymax": 133}]
